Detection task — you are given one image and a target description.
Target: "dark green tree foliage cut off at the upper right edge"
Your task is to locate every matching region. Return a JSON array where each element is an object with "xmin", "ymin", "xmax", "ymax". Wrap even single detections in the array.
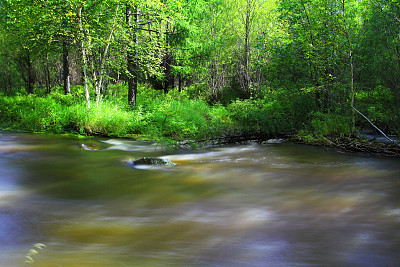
[{"xmin": 359, "ymin": 0, "xmax": 400, "ymax": 92}]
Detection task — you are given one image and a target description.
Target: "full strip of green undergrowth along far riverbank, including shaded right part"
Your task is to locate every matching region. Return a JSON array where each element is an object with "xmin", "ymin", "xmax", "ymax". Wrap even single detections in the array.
[{"xmin": 0, "ymin": 85, "xmax": 398, "ymax": 151}]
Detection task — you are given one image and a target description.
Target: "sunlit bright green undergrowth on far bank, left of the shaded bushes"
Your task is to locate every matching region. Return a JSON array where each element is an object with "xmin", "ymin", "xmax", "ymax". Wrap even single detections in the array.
[{"xmin": 0, "ymin": 88, "xmax": 229, "ymax": 141}]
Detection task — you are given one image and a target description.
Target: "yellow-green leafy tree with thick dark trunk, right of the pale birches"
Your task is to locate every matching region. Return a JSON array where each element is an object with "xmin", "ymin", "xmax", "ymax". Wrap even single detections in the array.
[{"xmin": 125, "ymin": 0, "xmax": 184, "ymax": 106}]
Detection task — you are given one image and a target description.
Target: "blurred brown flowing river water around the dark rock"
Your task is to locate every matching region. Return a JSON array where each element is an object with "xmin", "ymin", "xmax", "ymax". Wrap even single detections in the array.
[{"xmin": 0, "ymin": 132, "xmax": 400, "ymax": 267}]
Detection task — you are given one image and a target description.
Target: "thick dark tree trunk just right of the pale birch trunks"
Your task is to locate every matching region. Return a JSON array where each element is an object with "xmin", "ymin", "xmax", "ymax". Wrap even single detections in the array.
[{"xmin": 126, "ymin": 5, "xmax": 139, "ymax": 107}]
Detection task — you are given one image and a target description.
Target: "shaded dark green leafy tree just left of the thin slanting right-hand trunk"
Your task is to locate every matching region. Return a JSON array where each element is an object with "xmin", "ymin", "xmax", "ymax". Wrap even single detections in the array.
[{"xmin": 275, "ymin": 0, "xmax": 354, "ymax": 112}]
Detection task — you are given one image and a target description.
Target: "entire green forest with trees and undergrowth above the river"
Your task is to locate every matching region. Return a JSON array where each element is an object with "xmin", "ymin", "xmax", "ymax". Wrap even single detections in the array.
[{"xmin": 0, "ymin": 0, "xmax": 400, "ymax": 150}]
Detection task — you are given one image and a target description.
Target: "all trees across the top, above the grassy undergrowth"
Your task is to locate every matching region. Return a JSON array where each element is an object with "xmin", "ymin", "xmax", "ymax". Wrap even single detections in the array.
[{"xmin": 0, "ymin": 0, "xmax": 400, "ymax": 139}]
